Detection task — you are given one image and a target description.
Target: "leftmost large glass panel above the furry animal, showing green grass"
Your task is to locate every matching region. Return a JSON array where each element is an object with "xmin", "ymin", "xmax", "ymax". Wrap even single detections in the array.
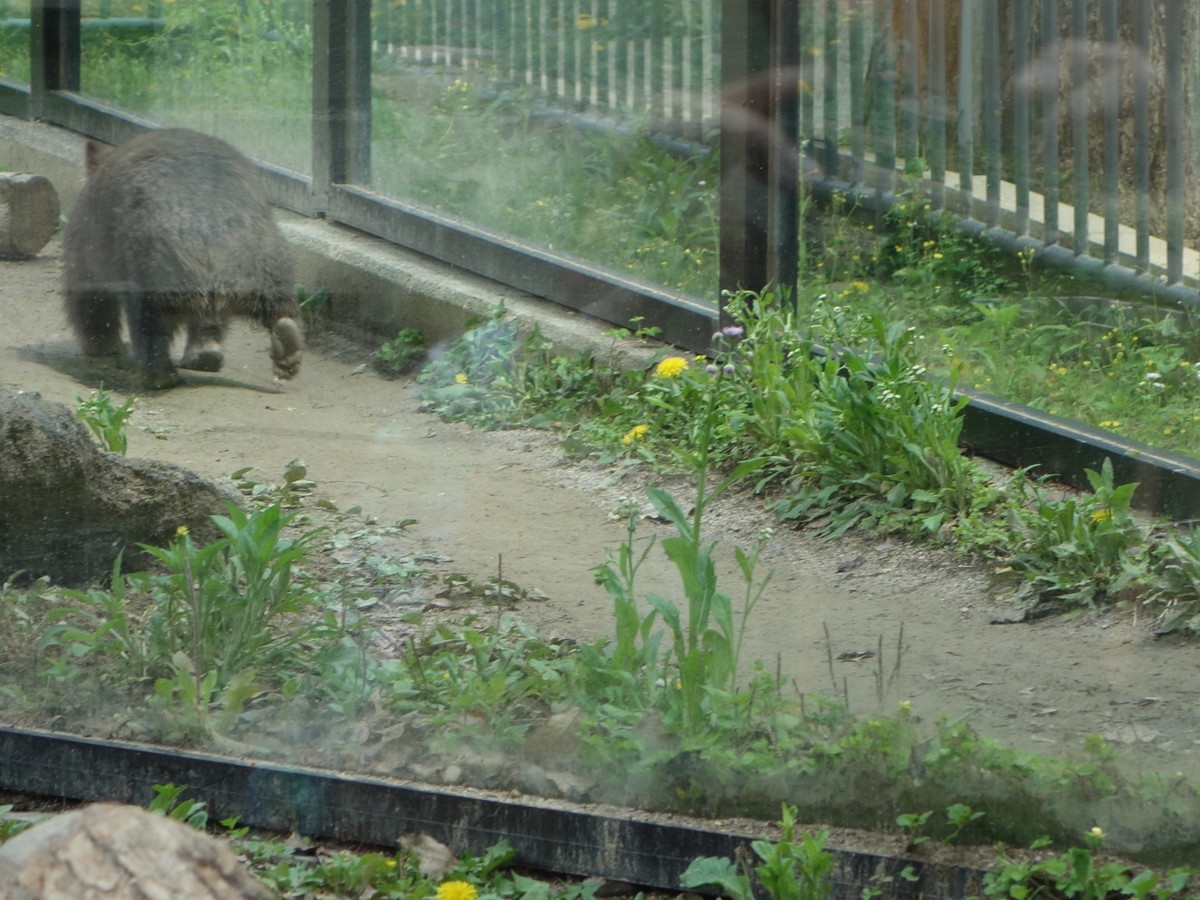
[{"xmin": 80, "ymin": 0, "xmax": 312, "ymax": 173}]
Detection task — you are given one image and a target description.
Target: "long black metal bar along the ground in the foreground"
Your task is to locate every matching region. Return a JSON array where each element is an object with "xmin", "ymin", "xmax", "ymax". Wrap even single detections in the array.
[{"xmin": 0, "ymin": 728, "xmax": 983, "ymax": 900}]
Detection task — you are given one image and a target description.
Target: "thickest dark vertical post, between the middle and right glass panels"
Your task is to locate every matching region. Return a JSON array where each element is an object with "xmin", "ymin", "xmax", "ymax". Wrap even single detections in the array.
[{"xmin": 719, "ymin": 0, "xmax": 799, "ymax": 309}]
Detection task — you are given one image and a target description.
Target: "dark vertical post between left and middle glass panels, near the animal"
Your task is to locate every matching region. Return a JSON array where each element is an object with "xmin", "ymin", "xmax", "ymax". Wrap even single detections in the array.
[{"xmin": 312, "ymin": 0, "xmax": 371, "ymax": 209}]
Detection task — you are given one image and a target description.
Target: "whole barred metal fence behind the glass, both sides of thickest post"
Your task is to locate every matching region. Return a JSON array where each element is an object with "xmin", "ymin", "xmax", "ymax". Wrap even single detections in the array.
[{"xmin": 373, "ymin": 0, "xmax": 1200, "ymax": 299}]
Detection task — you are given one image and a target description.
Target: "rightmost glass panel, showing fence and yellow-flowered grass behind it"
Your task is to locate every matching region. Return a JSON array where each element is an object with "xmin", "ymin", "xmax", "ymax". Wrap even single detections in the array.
[{"xmin": 802, "ymin": 2, "xmax": 1200, "ymax": 455}]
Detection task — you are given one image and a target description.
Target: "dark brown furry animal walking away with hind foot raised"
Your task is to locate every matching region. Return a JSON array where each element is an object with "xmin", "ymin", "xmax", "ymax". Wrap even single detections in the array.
[{"xmin": 64, "ymin": 128, "xmax": 304, "ymax": 388}]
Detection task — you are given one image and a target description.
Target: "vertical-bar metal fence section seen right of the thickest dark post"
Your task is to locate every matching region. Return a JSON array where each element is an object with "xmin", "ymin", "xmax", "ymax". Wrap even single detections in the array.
[{"xmin": 800, "ymin": 0, "xmax": 1200, "ymax": 292}]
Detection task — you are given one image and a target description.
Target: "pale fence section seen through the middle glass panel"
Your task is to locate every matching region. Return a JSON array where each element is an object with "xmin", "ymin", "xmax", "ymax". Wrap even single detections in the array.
[{"xmin": 372, "ymin": 0, "xmax": 720, "ymax": 139}]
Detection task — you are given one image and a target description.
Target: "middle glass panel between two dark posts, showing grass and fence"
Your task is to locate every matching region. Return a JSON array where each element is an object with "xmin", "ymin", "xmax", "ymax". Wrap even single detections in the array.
[{"xmin": 372, "ymin": 0, "xmax": 719, "ymax": 298}]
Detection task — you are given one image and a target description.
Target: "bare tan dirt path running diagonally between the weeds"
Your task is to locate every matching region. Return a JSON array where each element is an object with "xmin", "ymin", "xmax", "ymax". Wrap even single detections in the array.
[{"xmin": 0, "ymin": 236, "xmax": 1200, "ymax": 781}]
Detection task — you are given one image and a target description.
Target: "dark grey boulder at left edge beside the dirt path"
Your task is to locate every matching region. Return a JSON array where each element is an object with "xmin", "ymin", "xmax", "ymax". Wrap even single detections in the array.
[{"xmin": 0, "ymin": 388, "xmax": 239, "ymax": 584}]
